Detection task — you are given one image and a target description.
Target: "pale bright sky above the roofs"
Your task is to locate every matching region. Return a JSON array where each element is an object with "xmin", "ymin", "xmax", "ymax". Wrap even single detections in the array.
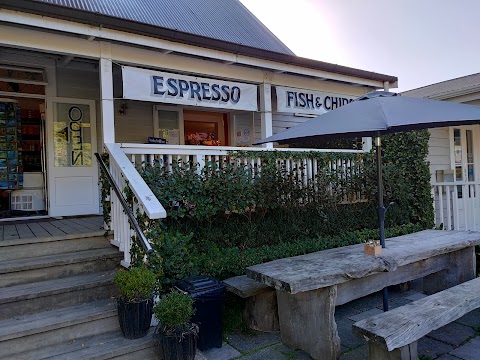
[{"xmin": 240, "ymin": 0, "xmax": 480, "ymax": 91}]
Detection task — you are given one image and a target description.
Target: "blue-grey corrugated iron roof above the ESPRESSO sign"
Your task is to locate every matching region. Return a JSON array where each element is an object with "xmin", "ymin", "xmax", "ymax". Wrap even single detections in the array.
[{"xmin": 35, "ymin": 0, "xmax": 293, "ymax": 55}]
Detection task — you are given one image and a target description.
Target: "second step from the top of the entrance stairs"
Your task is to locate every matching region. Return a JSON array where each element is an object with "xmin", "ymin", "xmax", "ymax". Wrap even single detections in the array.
[{"xmin": 0, "ymin": 246, "xmax": 123, "ymax": 287}]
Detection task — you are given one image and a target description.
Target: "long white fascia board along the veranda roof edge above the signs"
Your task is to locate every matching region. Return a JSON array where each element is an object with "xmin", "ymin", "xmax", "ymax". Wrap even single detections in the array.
[{"xmin": 0, "ymin": 9, "xmax": 383, "ymax": 88}]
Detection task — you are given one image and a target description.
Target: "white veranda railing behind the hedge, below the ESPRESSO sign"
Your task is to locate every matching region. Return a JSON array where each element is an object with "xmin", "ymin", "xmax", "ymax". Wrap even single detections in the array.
[{"xmin": 120, "ymin": 143, "xmax": 365, "ymax": 202}]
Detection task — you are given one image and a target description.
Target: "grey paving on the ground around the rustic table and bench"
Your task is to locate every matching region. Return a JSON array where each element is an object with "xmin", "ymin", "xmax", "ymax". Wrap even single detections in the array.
[{"xmin": 203, "ymin": 289, "xmax": 480, "ymax": 360}]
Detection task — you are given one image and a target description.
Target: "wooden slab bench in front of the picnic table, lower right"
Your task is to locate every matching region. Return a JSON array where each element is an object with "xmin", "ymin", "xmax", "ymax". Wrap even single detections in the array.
[{"xmin": 353, "ymin": 278, "xmax": 480, "ymax": 360}]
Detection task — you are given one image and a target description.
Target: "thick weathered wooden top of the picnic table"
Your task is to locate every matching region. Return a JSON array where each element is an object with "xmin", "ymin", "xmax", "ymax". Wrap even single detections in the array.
[{"xmin": 247, "ymin": 230, "xmax": 480, "ymax": 294}]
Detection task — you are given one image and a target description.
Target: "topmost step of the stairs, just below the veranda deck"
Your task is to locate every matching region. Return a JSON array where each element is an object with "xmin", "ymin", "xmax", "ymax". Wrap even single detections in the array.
[{"xmin": 0, "ymin": 234, "xmax": 110, "ymax": 261}]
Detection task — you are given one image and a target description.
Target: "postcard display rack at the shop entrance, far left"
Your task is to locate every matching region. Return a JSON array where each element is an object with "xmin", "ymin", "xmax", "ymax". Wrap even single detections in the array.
[{"xmin": 0, "ymin": 99, "xmax": 23, "ymax": 190}]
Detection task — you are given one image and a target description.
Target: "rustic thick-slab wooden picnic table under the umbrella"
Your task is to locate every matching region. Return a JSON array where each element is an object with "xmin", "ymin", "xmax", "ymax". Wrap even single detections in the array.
[{"xmin": 247, "ymin": 230, "xmax": 480, "ymax": 359}]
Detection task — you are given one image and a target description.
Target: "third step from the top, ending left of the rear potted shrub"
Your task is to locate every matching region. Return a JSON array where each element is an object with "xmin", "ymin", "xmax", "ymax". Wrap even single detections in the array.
[{"xmin": 0, "ymin": 271, "xmax": 116, "ymax": 320}]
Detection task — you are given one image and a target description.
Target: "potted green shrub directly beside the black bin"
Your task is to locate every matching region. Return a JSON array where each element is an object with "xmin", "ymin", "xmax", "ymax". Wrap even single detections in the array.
[{"xmin": 153, "ymin": 290, "xmax": 198, "ymax": 360}]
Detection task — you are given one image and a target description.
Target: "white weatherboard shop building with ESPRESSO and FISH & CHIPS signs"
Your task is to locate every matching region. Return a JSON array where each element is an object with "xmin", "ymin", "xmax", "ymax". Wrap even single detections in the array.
[{"xmin": 0, "ymin": 0, "xmax": 397, "ymax": 222}]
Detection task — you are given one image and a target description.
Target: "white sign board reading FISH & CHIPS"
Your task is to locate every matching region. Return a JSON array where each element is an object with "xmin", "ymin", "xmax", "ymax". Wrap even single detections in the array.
[{"xmin": 275, "ymin": 86, "xmax": 357, "ymax": 115}]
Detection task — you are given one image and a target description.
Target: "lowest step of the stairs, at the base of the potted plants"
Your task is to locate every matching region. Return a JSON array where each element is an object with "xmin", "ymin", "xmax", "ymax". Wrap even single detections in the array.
[{"xmin": 9, "ymin": 328, "xmax": 159, "ymax": 360}]
